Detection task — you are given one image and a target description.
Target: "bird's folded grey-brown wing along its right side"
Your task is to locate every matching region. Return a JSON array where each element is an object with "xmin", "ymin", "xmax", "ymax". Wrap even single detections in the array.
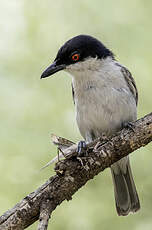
[{"xmin": 116, "ymin": 63, "xmax": 138, "ymax": 105}]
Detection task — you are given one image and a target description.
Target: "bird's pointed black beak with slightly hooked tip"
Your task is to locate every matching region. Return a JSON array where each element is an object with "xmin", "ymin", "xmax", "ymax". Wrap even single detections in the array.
[{"xmin": 41, "ymin": 61, "xmax": 65, "ymax": 78}]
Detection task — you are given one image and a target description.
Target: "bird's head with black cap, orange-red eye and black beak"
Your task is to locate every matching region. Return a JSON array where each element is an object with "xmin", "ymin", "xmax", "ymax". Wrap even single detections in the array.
[{"xmin": 41, "ymin": 35, "xmax": 113, "ymax": 78}]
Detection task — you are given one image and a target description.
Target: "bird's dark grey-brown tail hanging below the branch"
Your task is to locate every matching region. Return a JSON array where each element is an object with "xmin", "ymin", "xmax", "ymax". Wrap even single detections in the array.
[{"xmin": 111, "ymin": 157, "xmax": 140, "ymax": 216}]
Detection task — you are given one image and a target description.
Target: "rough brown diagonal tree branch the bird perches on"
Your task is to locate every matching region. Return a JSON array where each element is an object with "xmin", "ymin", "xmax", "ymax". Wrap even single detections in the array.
[{"xmin": 0, "ymin": 113, "xmax": 152, "ymax": 230}]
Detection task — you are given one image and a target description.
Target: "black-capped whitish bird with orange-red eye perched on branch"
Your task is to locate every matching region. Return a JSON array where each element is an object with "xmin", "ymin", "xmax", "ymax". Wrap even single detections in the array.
[{"xmin": 41, "ymin": 34, "xmax": 140, "ymax": 216}]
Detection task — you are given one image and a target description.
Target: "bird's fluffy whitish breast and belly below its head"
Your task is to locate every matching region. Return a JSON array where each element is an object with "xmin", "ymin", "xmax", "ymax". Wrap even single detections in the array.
[{"xmin": 67, "ymin": 56, "xmax": 136, "ymax": 141}]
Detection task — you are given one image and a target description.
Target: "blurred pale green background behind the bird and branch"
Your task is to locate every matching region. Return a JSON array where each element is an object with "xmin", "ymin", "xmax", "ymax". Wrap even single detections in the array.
[{"xmin": 0, "ymin": 0, "xmax": 152, "ymax": 230}]
